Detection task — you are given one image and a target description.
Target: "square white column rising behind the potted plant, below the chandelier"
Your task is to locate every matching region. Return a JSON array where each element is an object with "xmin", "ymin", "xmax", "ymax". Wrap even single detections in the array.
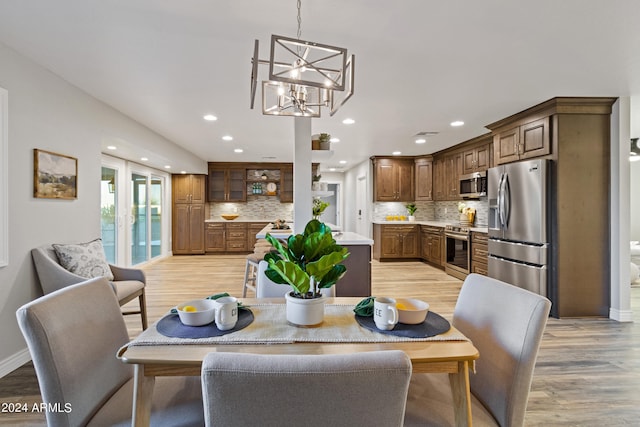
[{"xmin": 293, "ymin": 117, "xmax": 313, "ymax": 233}]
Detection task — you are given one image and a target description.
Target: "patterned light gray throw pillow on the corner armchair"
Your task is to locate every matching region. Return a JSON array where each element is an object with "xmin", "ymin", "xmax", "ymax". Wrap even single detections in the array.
[{"xmin": 52, "ymin": 239, "xmax": 113, "ymax": 280}]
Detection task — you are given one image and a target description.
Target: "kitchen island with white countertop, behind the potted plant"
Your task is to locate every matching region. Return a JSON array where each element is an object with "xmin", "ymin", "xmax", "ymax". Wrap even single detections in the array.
[{"xmin": 256, "ymin": 224, "xmax": 373, "ymax": 297}]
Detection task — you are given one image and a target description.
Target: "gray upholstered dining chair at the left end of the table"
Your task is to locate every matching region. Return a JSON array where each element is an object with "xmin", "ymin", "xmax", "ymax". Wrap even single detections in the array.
[{"xmin": 16, "ymin": 277, "xmax": 204, "ymax": 427}]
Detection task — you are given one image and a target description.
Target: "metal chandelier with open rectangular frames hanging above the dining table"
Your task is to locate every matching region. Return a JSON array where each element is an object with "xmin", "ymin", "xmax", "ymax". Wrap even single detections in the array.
[{"xmin": 251, "ymin": 0, "xmax": 355, "ymax": 117}]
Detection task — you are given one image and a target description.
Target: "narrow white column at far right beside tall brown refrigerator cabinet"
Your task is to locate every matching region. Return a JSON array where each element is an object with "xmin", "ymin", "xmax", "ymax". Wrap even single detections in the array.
[{"xmin": 609, "ymin": 97, "xmax": 633, "ymax": 322}]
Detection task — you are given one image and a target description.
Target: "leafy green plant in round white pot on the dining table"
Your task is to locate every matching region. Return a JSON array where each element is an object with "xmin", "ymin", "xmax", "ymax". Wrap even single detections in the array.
[{"xmin": 264, "ymin": 219, "xmax": 349, "ymax": 326}]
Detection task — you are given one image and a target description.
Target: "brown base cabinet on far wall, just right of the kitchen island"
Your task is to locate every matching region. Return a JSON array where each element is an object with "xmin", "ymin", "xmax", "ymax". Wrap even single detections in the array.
[{"xmin": 373, "ymin": 224, "xmax": 420, "ymax": 260}]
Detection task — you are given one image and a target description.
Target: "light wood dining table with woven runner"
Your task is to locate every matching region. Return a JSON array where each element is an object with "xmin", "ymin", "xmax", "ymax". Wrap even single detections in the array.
[{"xmin": 117, "ymin": 297, "xmax": 479, "ymax": 426}]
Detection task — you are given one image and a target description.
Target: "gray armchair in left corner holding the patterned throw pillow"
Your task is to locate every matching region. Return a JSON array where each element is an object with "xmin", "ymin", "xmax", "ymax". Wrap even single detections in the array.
[{"xmin": 31, "ymin": 245, "xmax": 147, "ymax": 329}]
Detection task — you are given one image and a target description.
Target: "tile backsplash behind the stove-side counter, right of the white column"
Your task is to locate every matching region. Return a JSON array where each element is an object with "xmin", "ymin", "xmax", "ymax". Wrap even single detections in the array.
[{"xmin": 372, "ymin": 200, "xmax": 489, "ymax": 227}]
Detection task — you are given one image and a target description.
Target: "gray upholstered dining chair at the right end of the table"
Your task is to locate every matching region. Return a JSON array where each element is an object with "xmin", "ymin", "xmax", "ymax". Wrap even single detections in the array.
[{"xmin": 405, "ymin": 274, "xmax": 551, "ymax": 426}]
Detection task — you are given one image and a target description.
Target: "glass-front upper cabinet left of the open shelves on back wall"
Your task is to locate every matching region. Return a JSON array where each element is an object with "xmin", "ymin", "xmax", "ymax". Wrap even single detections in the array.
[{"xmin": 207, "ymin": 163, "xmax": 247, "ymax": 202}]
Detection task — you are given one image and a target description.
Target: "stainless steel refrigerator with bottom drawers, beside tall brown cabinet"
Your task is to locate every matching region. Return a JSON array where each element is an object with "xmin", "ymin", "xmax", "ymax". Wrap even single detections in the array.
[{"xmin": 487, "ymin": 159, "xmax": 551, "ymax": 296}]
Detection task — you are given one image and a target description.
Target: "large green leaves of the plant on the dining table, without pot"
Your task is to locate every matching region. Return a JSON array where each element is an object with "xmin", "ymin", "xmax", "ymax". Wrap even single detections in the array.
[{"xmin": 264, "ymin": 219, "xmax": 349, "ymax": 298}]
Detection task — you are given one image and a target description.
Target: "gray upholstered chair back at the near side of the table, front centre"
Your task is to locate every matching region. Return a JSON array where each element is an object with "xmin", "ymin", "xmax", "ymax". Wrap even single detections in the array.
[{"xmin": 202, "ymin": 350, "xmax": 411, "ymax": 427}]
